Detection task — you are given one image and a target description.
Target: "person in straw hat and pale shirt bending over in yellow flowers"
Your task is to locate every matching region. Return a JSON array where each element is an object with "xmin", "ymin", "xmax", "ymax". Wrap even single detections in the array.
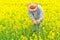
[{"xmin": 28, "ymin": 3, "xmax": 44, "ymax": 33}]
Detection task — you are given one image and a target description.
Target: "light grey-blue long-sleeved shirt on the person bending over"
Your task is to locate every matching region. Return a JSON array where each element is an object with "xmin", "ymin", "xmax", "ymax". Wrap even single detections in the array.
[{"xmin": 29, "ymin": 5, "xmax": 44, "ymax": 20}]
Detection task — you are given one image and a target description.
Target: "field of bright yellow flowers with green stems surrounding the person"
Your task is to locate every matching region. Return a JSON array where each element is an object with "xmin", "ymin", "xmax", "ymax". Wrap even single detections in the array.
[{"xmin": 0, "ymin": 0, "xmax": 60, "ymax": 40}]
